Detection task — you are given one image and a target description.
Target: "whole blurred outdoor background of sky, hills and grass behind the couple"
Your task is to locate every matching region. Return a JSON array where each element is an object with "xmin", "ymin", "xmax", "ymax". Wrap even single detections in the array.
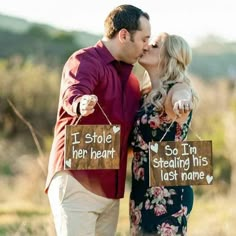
[{"xmin": 0, "ymin": 0, "xmax": 236, "ymax": 236}]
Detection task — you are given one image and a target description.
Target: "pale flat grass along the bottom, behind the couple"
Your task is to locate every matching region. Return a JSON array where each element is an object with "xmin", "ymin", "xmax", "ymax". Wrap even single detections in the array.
[{"xmin": 0, "ymin": 186, "xmax": 236, "ymax": 236}]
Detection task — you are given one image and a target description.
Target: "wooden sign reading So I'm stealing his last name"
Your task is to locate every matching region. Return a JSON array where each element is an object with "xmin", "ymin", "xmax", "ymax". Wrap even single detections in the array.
[{"xmin": 149, "ymin": 141, "xmax": 213, "ymax": 186}]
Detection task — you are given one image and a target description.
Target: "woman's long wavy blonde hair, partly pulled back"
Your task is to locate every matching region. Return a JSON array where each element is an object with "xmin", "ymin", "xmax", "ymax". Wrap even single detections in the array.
[{"xmin": 144, "ymin": 33, "xmax": 197, "ymax": 111}]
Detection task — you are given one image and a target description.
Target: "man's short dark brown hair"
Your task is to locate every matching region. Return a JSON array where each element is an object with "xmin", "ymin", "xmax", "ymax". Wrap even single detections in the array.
[{"xmin": 104, "ymin": 4, "xmax": 149, "ymax": 39}]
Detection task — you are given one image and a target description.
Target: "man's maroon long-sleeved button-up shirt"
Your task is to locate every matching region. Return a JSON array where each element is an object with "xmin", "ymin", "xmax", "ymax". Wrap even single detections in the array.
[{"xmin": 45, "ymin": 41, "xmax": 140, "ymax": 199}]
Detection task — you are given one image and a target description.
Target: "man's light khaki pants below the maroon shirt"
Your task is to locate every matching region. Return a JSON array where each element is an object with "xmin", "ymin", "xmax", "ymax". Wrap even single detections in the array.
[{"xmin": 48, "ymin": 171, "xmax": 120, "ymax": 236}]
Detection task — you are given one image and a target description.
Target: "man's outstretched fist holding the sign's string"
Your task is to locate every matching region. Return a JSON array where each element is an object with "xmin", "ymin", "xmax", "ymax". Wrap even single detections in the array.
[{"xmin": 79, "ymin": 94, "xmax": 98, "ymax": 116}]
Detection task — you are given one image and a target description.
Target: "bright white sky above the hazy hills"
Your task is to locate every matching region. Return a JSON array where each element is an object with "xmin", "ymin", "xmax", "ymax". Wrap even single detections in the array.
[{"xmin": 0, "ymin": 0, "xmax": 236, "ymax": 45}]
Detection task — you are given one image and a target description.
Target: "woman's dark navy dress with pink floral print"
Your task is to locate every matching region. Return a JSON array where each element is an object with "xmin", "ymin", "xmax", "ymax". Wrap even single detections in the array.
[{"xmin": 130, "ymin": 94, "xmax": 193, "ymax": 236}]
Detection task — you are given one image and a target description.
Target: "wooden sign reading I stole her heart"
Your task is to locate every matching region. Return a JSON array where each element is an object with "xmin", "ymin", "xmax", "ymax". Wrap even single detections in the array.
[{"xmin": 64, "ymin": 125, "xmax": 120, "ymax": 170}]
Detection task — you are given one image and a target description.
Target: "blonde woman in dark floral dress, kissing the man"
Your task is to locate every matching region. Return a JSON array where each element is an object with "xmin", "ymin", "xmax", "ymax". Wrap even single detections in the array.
[{"xmin": 130, "ymin": 33, "xmax": 197, "ymax": 236}]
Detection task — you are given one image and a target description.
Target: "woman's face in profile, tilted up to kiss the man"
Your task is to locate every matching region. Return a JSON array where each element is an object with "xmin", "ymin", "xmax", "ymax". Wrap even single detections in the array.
[{"xmin": 138, "ymin": 34, "xmax": 166, "ymax": 70}]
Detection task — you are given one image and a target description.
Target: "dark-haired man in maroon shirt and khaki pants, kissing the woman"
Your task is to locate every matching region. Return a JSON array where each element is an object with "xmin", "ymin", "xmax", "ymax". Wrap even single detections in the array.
[{"xmin": 45, "ymin": 5, "xmax": 151, "ymax": 236}]
